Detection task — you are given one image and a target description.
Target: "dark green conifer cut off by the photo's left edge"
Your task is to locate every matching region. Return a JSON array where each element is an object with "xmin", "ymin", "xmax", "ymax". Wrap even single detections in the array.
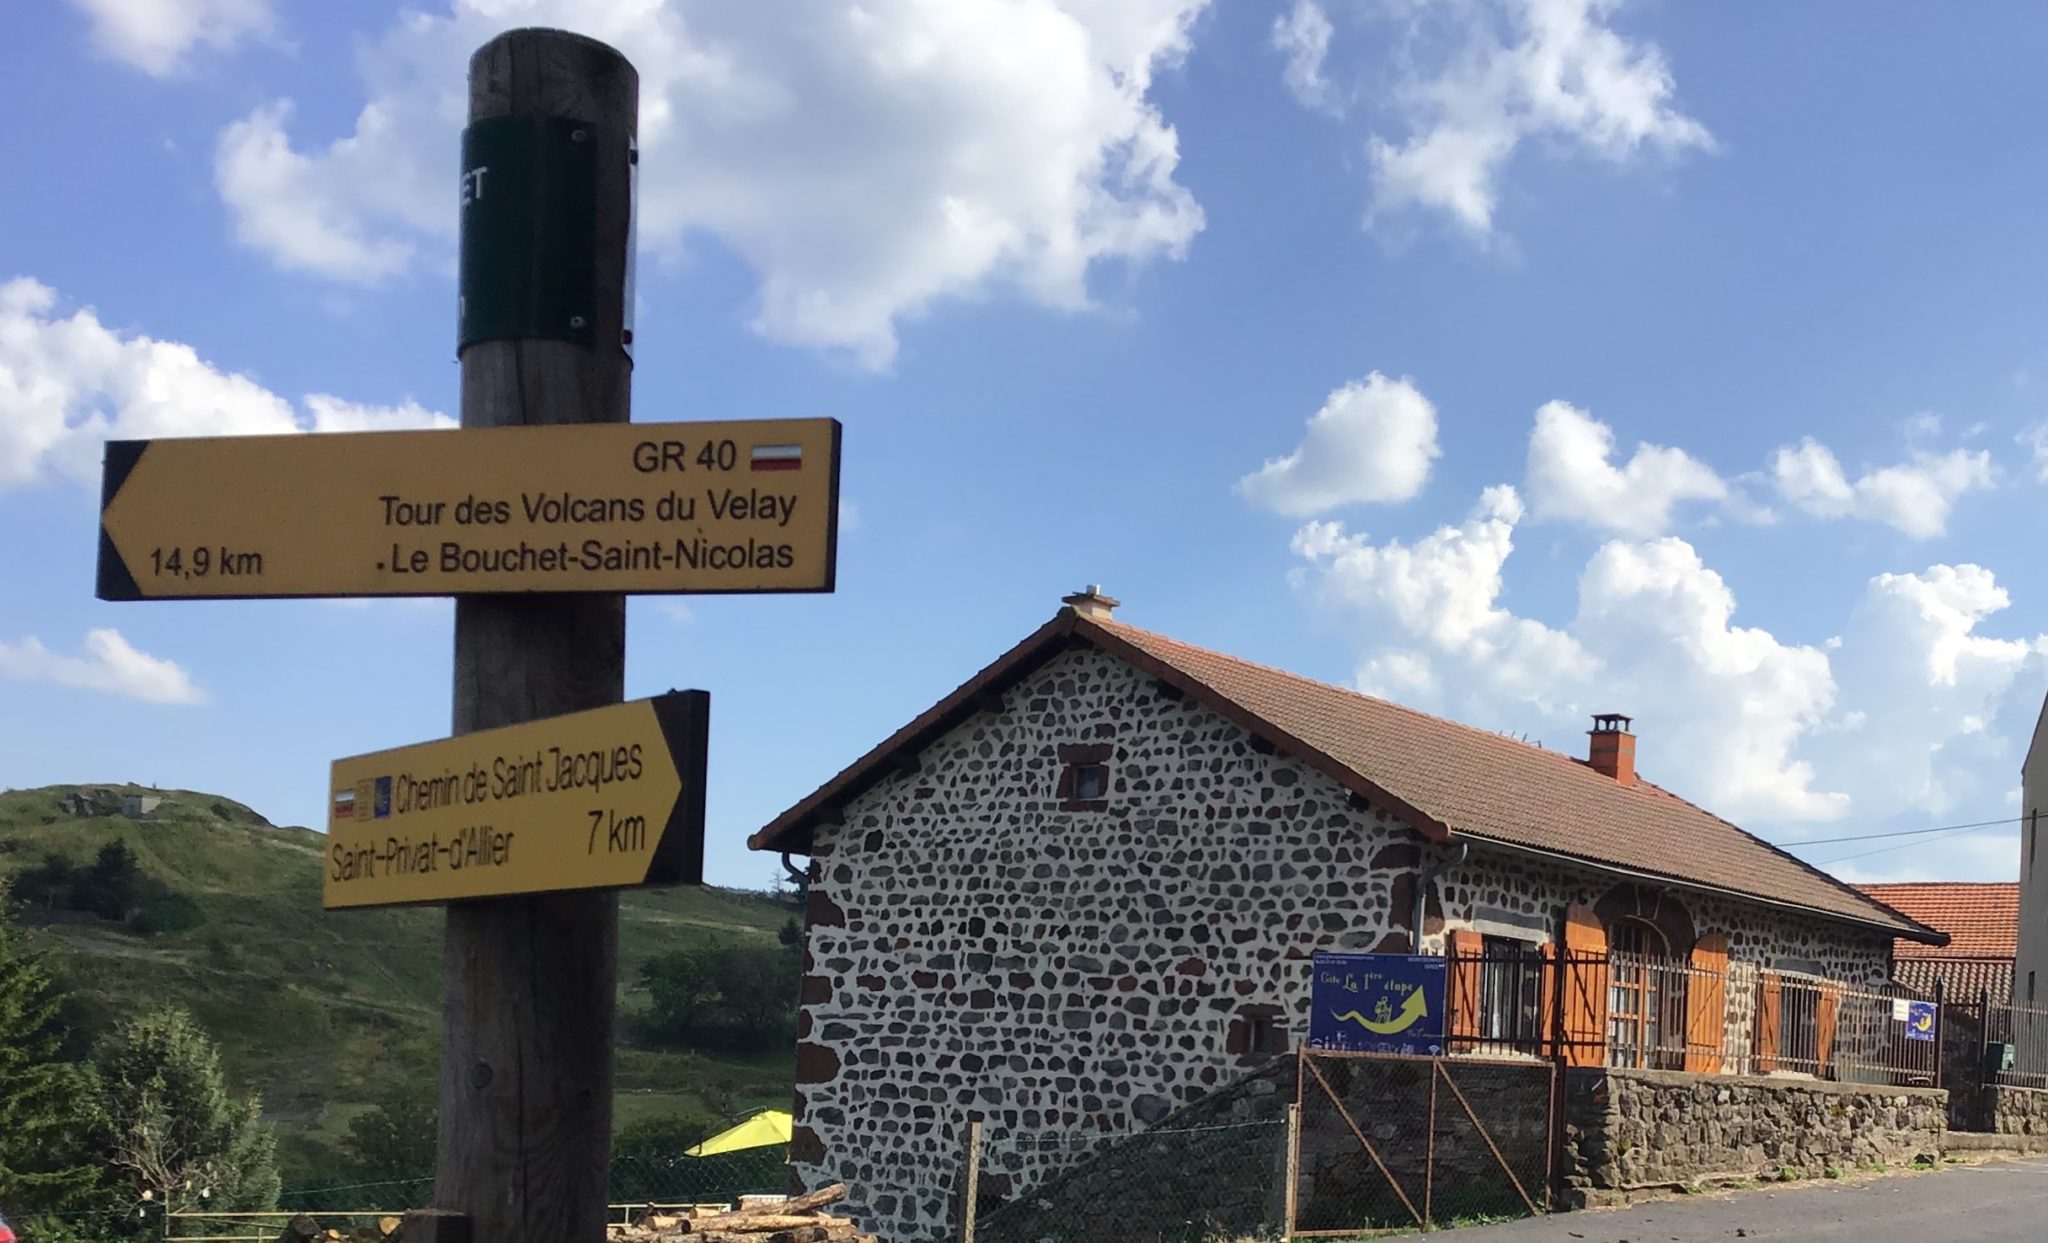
[{"xmin": 0, "ymin": 885, "xmax": 100, "ymax": 1220}]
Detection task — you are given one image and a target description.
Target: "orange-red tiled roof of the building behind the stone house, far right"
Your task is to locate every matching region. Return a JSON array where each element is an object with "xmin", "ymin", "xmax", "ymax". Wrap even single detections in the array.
[{"xmin": 1855, "ymin": 881, "xmax": 2019, "ymax": 1005}]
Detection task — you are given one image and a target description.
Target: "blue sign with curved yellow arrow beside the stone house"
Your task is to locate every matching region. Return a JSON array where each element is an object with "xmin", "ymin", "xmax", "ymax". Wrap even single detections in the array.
[{"xmin": 1309, "ymin": 954, "xmax": 1450, "ymax": 1057}]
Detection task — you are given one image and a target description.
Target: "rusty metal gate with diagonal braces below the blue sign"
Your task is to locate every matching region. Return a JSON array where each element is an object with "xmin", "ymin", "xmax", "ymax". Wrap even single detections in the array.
[{"xmin": 1286, "ymin": 1048, "xmax": 1559, "ymax": 1237}]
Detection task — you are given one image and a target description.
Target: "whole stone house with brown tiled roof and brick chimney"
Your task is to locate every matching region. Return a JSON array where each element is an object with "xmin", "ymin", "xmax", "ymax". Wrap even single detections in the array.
[{"xmin": 750, "ymin": 588, "xmax": 1944, "ymax": 1239}]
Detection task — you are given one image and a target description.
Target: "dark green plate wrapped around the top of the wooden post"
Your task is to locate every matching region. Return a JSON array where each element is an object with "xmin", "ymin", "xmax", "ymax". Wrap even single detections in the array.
[{"xmin": 455, "ymin": 117, "xmax": 598, "ymax": 354}]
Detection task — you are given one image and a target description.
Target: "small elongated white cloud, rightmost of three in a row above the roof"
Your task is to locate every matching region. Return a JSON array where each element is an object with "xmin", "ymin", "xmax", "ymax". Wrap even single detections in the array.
[{"xmin": 1772, "ymin": 436, "xmax": 1993, "ymax": 539}]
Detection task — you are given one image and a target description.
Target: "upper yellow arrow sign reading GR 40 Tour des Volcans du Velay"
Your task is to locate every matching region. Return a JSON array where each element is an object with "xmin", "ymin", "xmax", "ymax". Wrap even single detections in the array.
[{"xmin": 98, "ymin": 418, "xmax": 840, "ymax": 600}]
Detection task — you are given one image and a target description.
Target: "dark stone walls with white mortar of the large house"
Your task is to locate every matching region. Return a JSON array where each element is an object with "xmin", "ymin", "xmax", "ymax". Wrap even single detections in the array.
[{"xmin": 791, "ymin": 649, "xmax": 1886, "ymax": 1243}]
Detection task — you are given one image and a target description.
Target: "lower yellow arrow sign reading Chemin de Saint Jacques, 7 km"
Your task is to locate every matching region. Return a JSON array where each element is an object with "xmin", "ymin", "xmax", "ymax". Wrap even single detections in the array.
[{"xmin": 326, "ymin": 690, "xmax": 711, "ymax": 909}]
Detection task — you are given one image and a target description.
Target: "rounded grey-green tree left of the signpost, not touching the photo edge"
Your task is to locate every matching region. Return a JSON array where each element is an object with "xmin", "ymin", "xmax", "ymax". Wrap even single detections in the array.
[{"xmin": 92, "ymin": 1008, "xmax": 279, "ymax": 1236}]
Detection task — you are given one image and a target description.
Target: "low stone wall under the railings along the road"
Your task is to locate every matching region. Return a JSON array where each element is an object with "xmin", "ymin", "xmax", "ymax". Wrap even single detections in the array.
[{"xmin": 1565, "ymin": 1069, "xmax": 1948, "ymax": 1204}]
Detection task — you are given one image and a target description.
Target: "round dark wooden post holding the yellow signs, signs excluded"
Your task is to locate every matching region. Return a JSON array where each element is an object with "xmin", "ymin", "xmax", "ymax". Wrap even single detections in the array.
[{"xmin": 434, "ymin": 29, "xmax": 639, "ymax": 1243}]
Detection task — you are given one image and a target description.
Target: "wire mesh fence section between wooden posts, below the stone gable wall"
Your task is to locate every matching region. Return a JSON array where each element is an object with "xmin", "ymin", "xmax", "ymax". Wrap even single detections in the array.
[{"xmin": 963, "ymin": 1120, "xmax": 1288, "ymax": 1243}]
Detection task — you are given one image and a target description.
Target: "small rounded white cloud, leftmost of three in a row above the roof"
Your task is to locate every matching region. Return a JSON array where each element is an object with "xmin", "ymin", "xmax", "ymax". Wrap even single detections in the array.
[{"xmin": 1237, "ymin": 371, "xmax": 1440, "ymax": 518}]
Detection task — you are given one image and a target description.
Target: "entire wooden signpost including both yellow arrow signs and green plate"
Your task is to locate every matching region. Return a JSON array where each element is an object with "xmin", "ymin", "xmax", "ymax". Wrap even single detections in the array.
[{"xmin": 98, "ymin": 21, "xmax": 840, "ymax": 1243}]
